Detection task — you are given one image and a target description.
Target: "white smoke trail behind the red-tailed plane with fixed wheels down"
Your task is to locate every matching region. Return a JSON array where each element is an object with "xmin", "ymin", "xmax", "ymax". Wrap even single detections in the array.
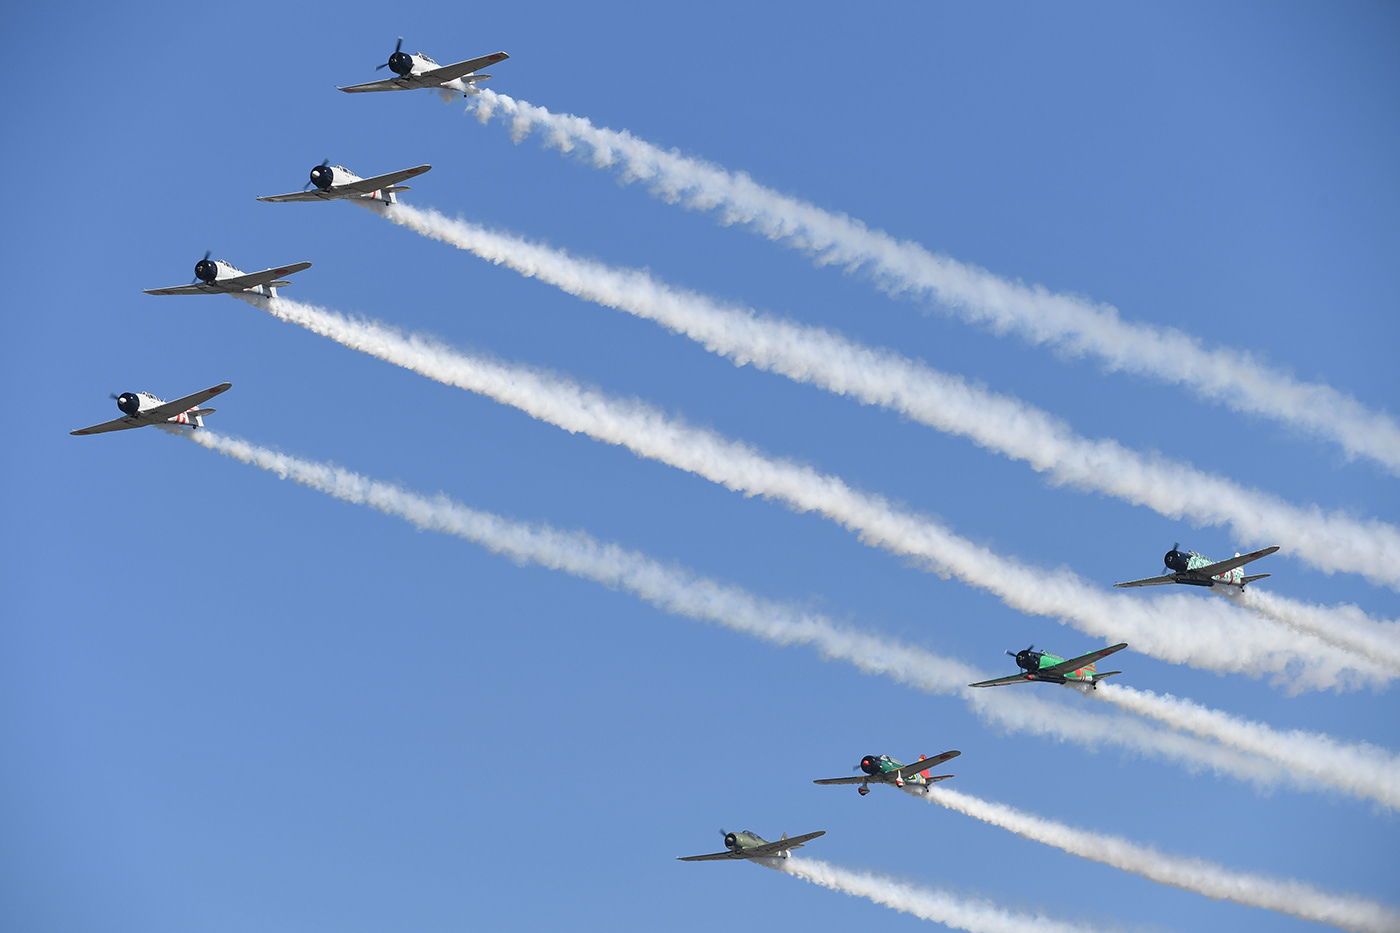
[{"xmin": 916, "ymin": 785, "xmax": 1400, "ymax": 933}]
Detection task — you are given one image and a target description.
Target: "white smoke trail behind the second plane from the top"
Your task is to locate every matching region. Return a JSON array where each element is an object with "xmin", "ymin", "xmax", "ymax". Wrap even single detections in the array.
[{"xmin": 372, "ymin": 202, "xmax": 1400, "ymax": 596}]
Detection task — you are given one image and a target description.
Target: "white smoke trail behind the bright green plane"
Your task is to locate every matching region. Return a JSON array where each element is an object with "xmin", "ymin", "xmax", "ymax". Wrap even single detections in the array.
[{"xmin": 1092, "ymin": 684, "xmax": 1400, "ymax": 810}]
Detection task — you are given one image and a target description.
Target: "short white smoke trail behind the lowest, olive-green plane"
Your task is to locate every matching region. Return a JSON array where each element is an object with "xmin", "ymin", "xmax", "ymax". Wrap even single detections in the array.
[{"xmin": 759, "ymin": 856, "xmax": 1096, "ymax": 933}]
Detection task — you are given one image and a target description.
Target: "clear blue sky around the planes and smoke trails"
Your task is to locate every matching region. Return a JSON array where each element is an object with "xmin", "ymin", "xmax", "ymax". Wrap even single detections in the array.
[{"xmin": 0, "ymin": 3, "xmax": 1400, "ymax": 930}]
